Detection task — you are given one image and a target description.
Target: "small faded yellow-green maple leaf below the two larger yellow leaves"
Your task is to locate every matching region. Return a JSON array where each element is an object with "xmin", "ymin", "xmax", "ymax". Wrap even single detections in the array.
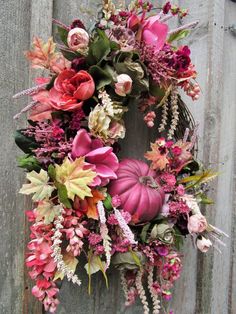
[{"xmin": 35, "ymin": 201, "xmax": 61, "ymax": 225}]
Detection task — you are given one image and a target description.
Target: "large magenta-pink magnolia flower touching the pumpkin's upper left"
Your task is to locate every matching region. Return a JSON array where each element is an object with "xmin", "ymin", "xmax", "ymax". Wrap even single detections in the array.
[{"xmin": 72, "ymin": 129, "xmax": 119, "ymax": 185}]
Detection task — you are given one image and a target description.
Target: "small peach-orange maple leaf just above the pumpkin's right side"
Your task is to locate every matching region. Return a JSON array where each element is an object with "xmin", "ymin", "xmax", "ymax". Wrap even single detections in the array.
[{"xmin": 144, "ymin": 143, "xmax": 169, "ymax": 170}]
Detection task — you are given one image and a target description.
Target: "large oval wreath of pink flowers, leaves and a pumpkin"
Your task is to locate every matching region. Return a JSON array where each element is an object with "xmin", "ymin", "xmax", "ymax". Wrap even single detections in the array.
[{"xmin": 14, "ymin": 0, "xmax": 227, "ymax": 314}]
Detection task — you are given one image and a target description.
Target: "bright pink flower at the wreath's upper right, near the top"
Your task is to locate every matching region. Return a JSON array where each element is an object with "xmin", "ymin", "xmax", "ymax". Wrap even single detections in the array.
[{"xmin": 142, "ymin": 15, "xmax": 168, "ymax": 52}]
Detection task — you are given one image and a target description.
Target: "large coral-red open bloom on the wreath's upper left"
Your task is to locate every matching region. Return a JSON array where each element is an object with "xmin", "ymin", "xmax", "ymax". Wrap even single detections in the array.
[{"xmin": 49, "ymin": 69, "xmax": 95, "ymax": 111}]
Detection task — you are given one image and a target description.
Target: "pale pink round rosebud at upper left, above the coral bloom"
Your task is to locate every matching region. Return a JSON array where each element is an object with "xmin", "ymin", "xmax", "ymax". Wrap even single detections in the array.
[{"xmin": 67, "ymin": 27, "xmax": 89, "ymax": 51}]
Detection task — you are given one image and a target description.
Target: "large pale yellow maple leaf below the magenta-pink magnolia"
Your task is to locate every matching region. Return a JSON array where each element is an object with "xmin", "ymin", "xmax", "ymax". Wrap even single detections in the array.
[{"xmin": 55, "ymin": 157, "xmax": 96, "ymax": 200}]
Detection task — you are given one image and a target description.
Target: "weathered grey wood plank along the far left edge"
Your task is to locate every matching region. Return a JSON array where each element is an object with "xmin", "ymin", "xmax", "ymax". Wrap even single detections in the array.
[{"xmin": 0, "ymin": 0, "xmax": 30, "ymax": 314}]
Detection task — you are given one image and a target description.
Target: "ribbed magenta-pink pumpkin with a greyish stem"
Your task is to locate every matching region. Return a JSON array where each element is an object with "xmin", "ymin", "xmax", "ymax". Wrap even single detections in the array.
[{"xmin": 108, "ymin": 159, "xmax": 165, "ymax": 223}]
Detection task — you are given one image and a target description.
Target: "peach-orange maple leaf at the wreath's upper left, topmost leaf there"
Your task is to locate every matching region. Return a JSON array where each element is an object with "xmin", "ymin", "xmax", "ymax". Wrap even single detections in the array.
[{"xmin": 25, "ymin": 37, "xmax": 56, "ymax": 68}]
